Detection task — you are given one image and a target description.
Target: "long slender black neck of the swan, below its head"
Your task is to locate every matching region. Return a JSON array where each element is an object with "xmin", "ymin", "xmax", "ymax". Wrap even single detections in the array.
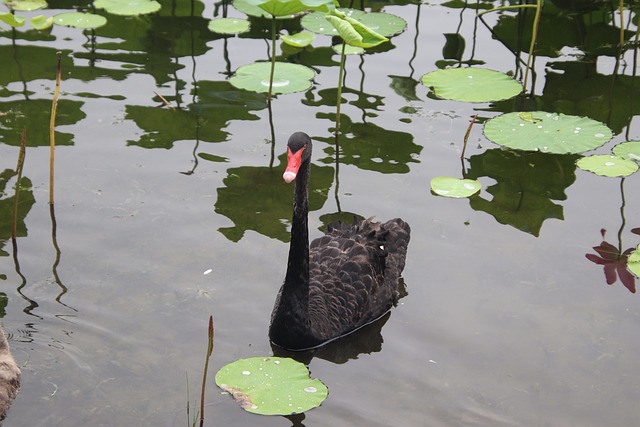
[{"xmin": 284, "ymin": 160, "xmax": 311, "ymax": 306}]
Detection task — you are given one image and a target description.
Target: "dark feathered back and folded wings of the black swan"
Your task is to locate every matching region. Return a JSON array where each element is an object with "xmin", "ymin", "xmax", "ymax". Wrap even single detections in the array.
[{"xmin": 309, "ymin": 218, "xmax": 410, "ymax": 340}]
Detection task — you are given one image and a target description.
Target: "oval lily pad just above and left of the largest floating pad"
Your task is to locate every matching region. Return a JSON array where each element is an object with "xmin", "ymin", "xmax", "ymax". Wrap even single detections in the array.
[{"xmin": 422, "ymin": 68, "xmax": 522, "ymax": 102}]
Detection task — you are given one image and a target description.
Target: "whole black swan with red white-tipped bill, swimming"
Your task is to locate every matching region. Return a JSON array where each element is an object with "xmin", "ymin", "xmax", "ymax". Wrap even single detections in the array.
[{"xmin": 269, "ymin": 132, "xmax": 410, "ymax": 351}]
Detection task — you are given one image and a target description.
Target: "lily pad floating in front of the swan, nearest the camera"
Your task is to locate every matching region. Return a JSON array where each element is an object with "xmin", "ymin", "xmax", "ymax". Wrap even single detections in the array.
[{"xmin": 216, "ymin": 357, "xmax": 329, "ymax": 415}]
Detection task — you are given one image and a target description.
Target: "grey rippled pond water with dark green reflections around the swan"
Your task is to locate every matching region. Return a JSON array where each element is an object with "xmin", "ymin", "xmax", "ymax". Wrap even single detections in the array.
[{"xmin": 0, "ymin": 1, "xmax": 640, "ymax": 427}]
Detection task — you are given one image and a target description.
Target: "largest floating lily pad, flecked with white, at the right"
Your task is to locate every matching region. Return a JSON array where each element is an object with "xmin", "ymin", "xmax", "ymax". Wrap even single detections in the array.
[{"xmin": 484, "ymin": 111, "xmax": 612, "ymax": 154}]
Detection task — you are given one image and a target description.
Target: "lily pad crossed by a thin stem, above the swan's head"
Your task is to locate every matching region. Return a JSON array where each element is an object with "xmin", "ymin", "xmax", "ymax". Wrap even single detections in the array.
[{"xmin": 229, "ymin": 62, "xmax": 316, "ymax": 93}]
